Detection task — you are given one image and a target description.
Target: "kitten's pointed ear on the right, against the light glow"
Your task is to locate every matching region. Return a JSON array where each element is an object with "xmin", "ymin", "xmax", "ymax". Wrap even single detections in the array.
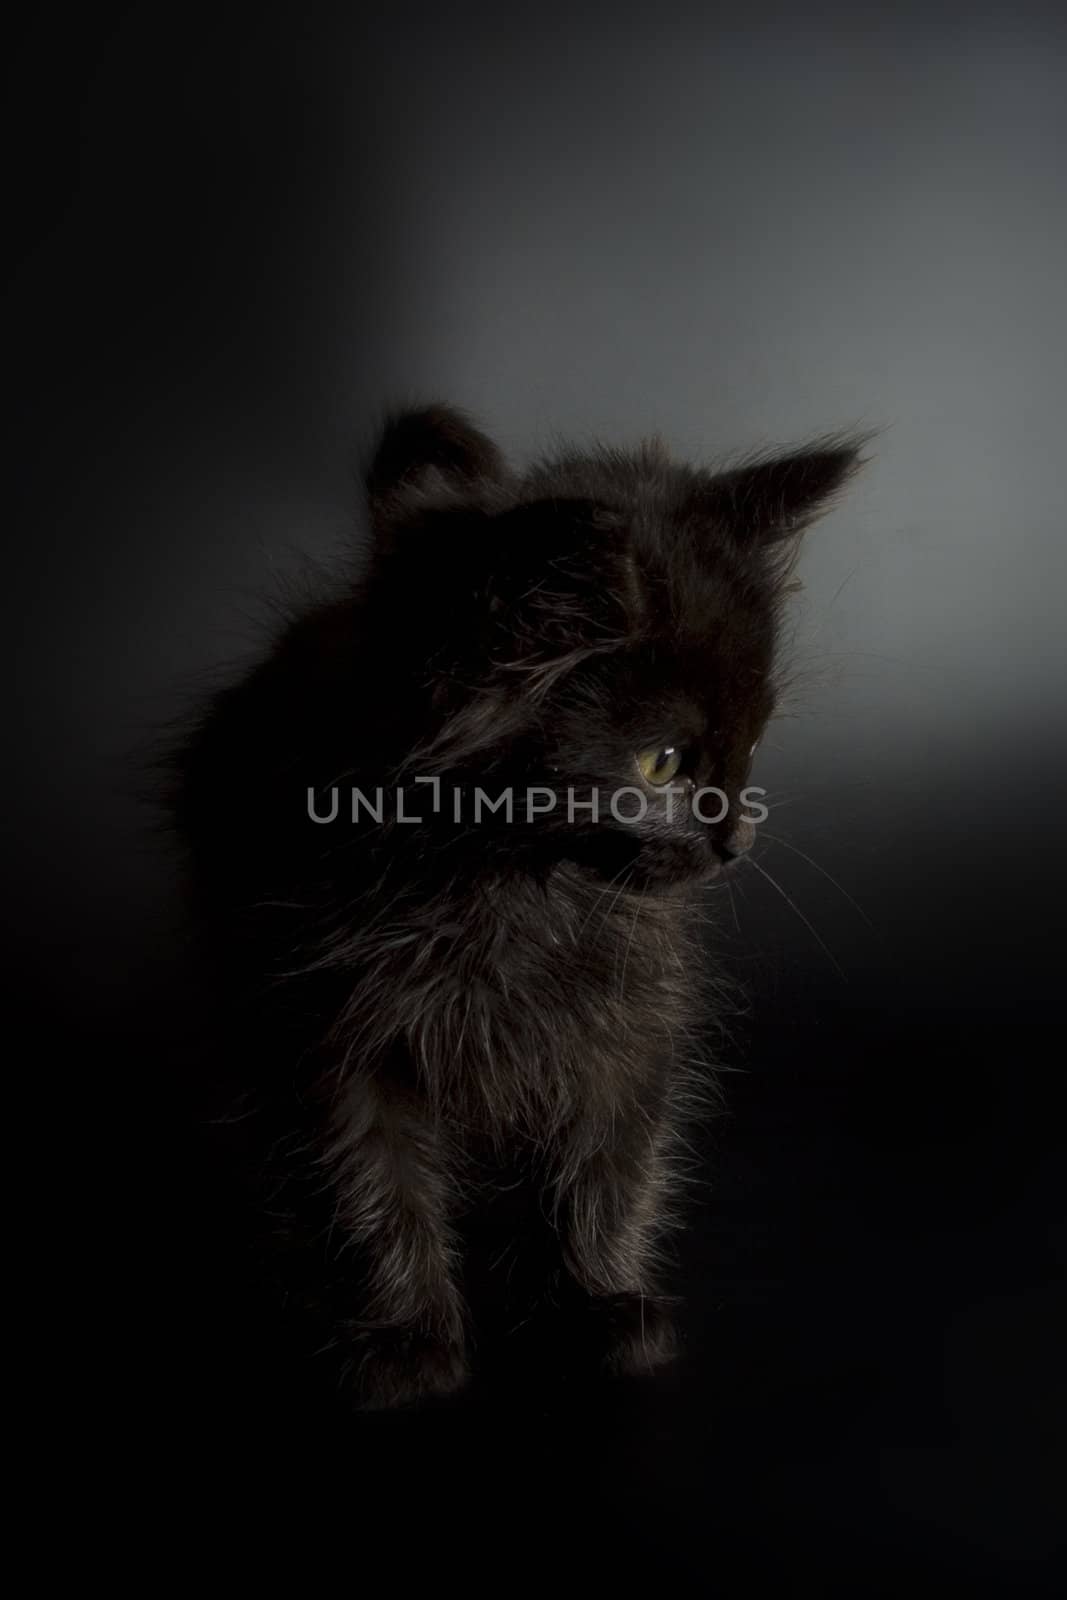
[{"xmin": 697, "ymin": 437, "xmax": 867, "ymax": 544}]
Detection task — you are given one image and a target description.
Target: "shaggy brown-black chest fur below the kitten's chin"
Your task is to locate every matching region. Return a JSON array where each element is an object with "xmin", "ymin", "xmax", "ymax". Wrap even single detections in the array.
[{"xmin": 335, "ymin": 870, "xmax": 705, "ymax": 1141}]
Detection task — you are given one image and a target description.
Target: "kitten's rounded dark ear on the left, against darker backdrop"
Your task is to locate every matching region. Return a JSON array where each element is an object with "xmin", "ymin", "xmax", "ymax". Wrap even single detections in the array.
[{"xmin": 366, "ymin": 405, "xmax": 507, "ymax": 517}]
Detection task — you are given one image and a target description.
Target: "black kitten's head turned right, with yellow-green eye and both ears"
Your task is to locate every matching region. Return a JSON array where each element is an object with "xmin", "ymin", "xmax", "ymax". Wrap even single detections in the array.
[{"xmin": 358, "ymin": 406, "xmax": 859, "ymax": 885}]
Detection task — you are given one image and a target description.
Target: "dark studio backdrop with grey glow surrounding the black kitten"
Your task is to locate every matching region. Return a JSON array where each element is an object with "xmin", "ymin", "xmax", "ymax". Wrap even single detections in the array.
[{"xmin": 5, "ymin": 3, "xmax": 1067, "ymax": 1595}]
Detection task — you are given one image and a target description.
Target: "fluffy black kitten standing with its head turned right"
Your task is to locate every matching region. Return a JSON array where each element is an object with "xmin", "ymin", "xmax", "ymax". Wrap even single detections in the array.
[{"xmin": 176, "ymin": 406, "xmax": 857, "ymax": 1405}]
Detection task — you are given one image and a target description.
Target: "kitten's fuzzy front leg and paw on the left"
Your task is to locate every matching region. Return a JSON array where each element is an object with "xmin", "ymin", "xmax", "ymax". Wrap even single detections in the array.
[{"xmin": 330, "ymin": 1080, "xmax": 469, "ymax": 1408}]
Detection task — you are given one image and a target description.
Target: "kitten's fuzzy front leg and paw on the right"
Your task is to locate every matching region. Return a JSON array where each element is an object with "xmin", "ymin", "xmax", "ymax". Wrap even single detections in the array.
[{"xmin": 557, "ymin": 1117, "xmax": 677, "ymax": 1373}]
